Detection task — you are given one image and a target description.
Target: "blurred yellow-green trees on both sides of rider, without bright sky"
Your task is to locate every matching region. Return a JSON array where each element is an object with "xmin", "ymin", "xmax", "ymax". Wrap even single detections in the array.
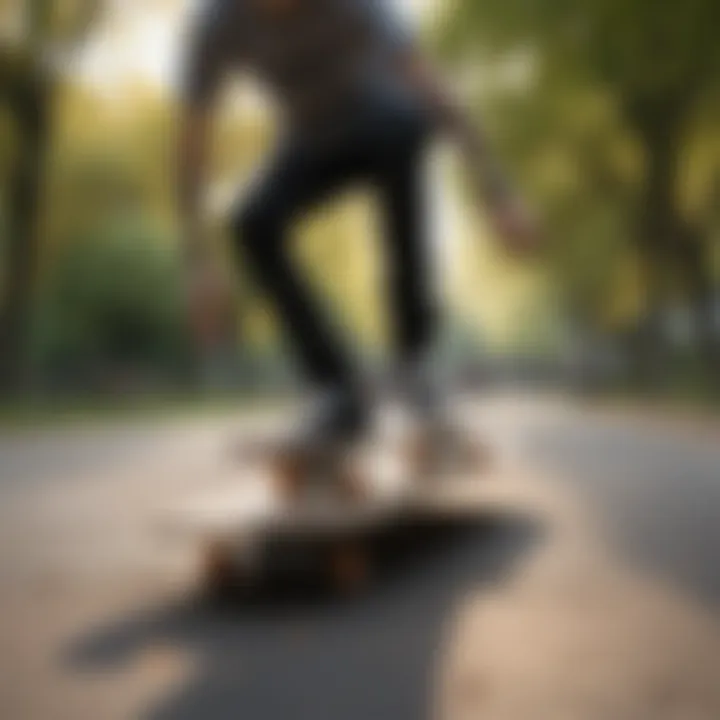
[{"xmin": 0, "ymin": 0, "xmax": 720, "ymax": 400}]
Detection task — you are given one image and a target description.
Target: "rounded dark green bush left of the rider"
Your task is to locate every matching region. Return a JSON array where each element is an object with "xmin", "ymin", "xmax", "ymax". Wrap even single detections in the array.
[{"xmin": 36, "ymin": 221, "xmax": 187, "ymax": 377}]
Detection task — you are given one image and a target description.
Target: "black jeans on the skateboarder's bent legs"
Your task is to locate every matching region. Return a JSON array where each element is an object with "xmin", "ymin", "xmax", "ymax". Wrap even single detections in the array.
[{"xmin": 234, "ymin": 90, "xmax": 435, "ymax": 394}]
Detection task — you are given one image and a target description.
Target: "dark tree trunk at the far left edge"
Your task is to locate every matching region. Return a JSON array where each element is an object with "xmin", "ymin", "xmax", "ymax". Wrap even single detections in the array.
[{"xmin": 0, "ymin": 78, "xmax": 51, "ymax": 395}]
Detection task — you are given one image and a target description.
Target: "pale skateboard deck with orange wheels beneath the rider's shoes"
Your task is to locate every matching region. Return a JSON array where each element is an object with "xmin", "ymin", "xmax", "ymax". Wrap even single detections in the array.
[{"xmin": 160, "ymin": 410, "xmax": 492, "ymax": 593}]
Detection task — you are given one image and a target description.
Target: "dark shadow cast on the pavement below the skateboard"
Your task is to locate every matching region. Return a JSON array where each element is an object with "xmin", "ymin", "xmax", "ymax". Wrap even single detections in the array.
[{"xmin": 63, "ymin": 512, "xmax": 542, "ymax": 720}]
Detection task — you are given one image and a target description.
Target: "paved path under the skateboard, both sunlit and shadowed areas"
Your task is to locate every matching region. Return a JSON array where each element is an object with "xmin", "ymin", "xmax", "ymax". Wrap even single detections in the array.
[{"xmin": 0, "ymin": 398, "xmax": 720, "ymax": 720}]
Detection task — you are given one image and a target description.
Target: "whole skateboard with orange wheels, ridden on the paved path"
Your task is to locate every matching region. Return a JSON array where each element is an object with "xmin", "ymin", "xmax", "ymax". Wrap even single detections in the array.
[{"xmin": 162, "ymin": 410, "xmax": 486, "ymax": 596}]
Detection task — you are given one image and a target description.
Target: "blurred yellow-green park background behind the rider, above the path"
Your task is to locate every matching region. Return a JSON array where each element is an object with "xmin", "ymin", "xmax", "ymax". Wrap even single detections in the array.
[{"xmin": 0, "ymin": 0, "xmax": 720, "ymax": 414}]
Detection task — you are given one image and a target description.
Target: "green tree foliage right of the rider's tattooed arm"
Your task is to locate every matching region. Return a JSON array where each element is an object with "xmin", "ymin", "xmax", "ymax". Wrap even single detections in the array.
[{"xmin": 442, "ymin": 0, "xmax": 720, "ymax": 382}]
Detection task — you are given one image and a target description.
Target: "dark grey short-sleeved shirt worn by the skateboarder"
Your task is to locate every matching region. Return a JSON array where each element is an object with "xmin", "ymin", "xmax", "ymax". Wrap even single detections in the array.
[{"xmin": 183, "ymin": 0, "xmax": 412, "ymax": 130}]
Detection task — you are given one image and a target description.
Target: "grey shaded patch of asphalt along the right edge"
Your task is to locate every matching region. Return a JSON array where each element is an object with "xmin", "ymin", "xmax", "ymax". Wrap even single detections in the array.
[{"xmin": 517, "ymin": 405, "xmax": 720, "ymax": 606}]
